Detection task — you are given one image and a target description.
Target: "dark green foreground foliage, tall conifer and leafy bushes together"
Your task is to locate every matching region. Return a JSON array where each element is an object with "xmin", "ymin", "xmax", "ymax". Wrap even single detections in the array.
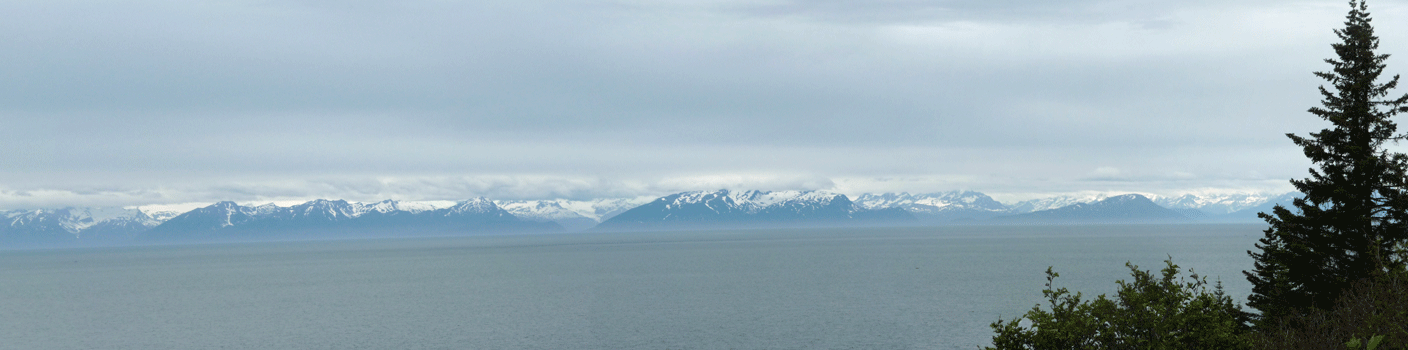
[{"xmin": 991, "ymin": 0, "xmax": 1408, "ymax": 350}]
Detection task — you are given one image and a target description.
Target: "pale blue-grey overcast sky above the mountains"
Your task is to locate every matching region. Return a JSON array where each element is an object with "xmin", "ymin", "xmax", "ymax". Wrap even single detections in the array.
[{"xmin": 0, "ymin": 0, "xmax": 1408, "ymax": 209}]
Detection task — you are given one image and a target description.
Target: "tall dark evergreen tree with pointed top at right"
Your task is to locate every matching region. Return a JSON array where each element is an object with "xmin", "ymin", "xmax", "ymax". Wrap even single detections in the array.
[{"xmin": 1245, "ymin": 0, "xmax": 1408, "ymax": 325}]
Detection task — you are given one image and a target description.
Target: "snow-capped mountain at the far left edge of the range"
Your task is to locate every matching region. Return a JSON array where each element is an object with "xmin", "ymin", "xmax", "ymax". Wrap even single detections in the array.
[{"xmin": 0, "ymin": 208, "xmax": 161, "ymax": 246}]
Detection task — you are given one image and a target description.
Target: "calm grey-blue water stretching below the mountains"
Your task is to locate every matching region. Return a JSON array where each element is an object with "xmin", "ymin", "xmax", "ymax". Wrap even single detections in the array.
[{"xmin": 0, "ymin": 225, "xmax": 1260, "ymax": 349}]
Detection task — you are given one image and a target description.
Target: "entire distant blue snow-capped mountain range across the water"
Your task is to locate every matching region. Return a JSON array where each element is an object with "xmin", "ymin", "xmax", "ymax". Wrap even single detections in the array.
[{"xmin": 0, "ymin": 190, "xmax": 1298, "ymax": 247}]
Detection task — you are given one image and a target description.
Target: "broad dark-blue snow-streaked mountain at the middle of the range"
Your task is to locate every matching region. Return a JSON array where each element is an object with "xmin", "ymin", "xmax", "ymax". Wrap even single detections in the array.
[{"xmin": 597, "ymin": 190, "xmax": 915, "ymax": 229}]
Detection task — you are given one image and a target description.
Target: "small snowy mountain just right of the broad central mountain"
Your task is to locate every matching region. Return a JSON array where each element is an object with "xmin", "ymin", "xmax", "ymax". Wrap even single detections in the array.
[{"xmin": 855, "ymin": 191, "xmax": 1008, "ymax": 222}]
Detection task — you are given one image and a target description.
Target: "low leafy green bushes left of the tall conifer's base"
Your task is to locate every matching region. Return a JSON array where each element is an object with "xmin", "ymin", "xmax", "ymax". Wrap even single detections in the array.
[{"xmin": 990, "ymin": 259, "xmax": 1250, "ymax": 350}]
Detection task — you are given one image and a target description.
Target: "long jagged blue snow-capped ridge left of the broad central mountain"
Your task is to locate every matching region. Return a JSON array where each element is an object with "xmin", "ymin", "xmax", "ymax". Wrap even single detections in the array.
[{"xmin": 141, "ymin": 198, "xmax": 562, "ymax": 240}]
